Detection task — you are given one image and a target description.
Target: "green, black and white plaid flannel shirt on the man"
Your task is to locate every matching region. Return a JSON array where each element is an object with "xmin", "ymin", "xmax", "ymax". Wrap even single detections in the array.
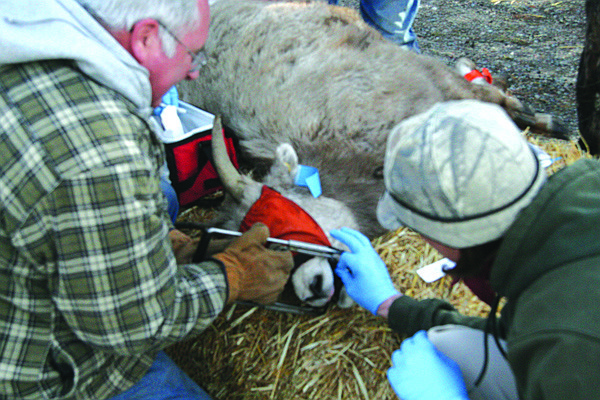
[{"xmin": 0, "ymin": 61, "xmax": 227, "ymax": 399}]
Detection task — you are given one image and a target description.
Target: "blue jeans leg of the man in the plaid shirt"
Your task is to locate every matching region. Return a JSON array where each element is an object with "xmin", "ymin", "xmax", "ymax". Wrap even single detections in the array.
[{"xmin": 110, "ymin": 351, "xmax": 212, "ymax": 400}]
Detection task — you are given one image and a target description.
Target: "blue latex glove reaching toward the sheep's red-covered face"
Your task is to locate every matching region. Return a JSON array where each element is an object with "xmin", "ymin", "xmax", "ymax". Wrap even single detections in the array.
[{"xmin": 329, "ymin": 228, "xmax": 399, "ymax": 315}]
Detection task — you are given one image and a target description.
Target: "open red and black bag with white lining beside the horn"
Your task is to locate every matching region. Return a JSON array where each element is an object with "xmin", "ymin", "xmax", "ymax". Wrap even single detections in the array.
[{"xmin": 165, "ymin": 102, "xmax": 239, "ymax": 208}]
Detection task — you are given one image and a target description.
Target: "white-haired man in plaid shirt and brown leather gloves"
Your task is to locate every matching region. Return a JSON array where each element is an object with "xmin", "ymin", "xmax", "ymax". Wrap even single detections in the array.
[{"xmin": 0, "ymin": 0, "xmax": 292, "ymax": 399}]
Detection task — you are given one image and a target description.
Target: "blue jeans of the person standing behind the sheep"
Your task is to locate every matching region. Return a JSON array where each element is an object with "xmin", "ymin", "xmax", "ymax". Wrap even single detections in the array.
[{"xmin": 328, "ymin": 0, "xmax": 421, "ymax": 53}]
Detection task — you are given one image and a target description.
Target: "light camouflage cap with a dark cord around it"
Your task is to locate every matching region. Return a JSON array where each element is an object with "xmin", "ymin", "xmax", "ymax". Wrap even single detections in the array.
[{"xmin": 377, "ymin": 100, "xmax": 546, "ymax": 248}]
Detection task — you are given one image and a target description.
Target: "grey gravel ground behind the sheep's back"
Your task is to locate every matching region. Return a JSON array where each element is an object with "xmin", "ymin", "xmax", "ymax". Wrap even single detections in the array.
[{"xmin": 340, "ymin": 0, "xmax": 585, "ymax": 136}]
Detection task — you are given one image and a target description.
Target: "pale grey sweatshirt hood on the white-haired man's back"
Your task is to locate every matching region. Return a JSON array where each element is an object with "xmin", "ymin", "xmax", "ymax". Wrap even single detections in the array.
[{"xmin": 0, "ymin": 0, "xmax": 152, "ymax": 114}]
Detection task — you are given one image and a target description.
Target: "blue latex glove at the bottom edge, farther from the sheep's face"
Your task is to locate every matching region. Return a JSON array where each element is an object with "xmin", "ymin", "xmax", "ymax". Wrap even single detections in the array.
[{"xmin": 387, "ymin": 331, "xmax": 469, "ymax": 400}]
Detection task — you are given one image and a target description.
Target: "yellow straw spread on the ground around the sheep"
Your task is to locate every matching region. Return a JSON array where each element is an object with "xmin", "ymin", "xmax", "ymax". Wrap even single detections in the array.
[{"xmin": 167, "ymin": 137, "xmax": 589, "ymax": 400}]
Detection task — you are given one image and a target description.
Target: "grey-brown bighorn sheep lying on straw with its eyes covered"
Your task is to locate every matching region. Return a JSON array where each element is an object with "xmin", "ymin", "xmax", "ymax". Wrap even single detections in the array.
[{"xmin": 178, "ymin": 0, "xmax": 568, "ymax": 301}]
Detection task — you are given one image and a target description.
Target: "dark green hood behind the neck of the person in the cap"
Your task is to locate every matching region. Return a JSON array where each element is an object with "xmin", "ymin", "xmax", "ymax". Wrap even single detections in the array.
[{"xmin": 490, "ymin": 159, "xmax": 600, "ymax": 301}]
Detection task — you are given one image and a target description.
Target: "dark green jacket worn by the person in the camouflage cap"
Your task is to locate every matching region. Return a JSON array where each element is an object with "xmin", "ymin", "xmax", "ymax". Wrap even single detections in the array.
[{"xmin": 389, "ymin": 160, "xmax": 600, "ymax": 400}]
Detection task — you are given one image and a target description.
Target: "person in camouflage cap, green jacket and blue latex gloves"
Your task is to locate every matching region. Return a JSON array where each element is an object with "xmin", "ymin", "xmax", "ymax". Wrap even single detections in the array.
[{"xmin": 331, "ymin": 100, "xmax": 600, "ymax": 400}]
